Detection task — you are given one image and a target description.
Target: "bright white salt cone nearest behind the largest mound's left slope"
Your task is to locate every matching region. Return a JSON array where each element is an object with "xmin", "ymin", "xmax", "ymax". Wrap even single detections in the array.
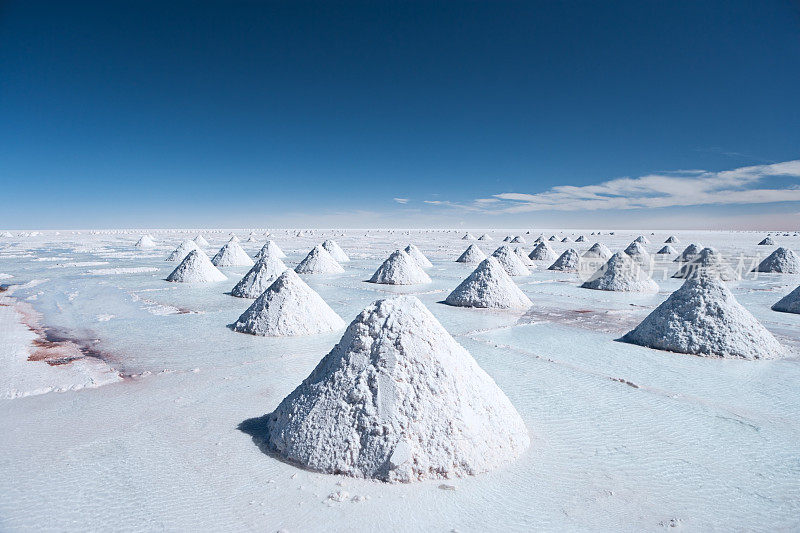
[{"xmin": 233, "ymin": 269, "xmax": 345, "ymax": 337}]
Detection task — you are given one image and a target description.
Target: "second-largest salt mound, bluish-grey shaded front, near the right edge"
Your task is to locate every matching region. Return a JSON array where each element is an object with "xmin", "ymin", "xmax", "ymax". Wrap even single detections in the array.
[{"xmin": 620, "ymin": 274, "xmax": 785, "ymax": 359}]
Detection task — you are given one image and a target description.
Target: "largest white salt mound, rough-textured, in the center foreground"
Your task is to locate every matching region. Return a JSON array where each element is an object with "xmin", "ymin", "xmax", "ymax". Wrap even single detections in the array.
[{"xmin": 266, "ymin": 296, "xmax": 530, "ymax": 482}]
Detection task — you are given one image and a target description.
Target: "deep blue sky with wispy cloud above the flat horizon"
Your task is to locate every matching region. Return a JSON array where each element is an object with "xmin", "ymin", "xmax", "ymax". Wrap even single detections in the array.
[{"xmin": 0, "ymin": 0, "xmax": 800, "ymax": 229}]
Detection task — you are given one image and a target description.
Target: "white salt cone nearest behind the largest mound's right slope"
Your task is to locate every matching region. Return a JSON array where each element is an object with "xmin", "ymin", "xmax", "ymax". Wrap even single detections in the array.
[{"xmin": 445, "ymin": 257, "xmax": 533, "ymax": 309}]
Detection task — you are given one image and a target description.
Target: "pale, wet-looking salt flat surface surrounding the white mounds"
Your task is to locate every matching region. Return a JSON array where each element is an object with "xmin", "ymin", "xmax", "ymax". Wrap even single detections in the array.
[{"xmin": 0, "ymin": 229, "xmax": 800, "ymax": 531}]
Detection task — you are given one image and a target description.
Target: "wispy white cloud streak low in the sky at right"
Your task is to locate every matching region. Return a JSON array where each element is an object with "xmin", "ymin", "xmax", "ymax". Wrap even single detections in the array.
[{"xmin": 418, "ymin": 160, "xmax": 800, "ymax": 213}]
